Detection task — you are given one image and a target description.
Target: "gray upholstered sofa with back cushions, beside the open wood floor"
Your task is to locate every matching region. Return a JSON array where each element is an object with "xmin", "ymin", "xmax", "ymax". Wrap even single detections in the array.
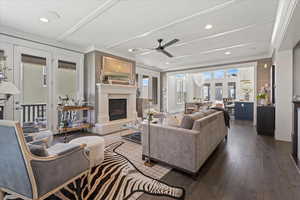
[{"xmin": 142, "ymin": 110, "xmax": 228, "ymax": 175}]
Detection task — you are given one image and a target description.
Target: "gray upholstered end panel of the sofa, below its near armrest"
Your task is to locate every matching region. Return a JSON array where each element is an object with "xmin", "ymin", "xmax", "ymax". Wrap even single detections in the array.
[{"xmin": 142, "ymin": 124, "xmax": 199, "ymax": 172}]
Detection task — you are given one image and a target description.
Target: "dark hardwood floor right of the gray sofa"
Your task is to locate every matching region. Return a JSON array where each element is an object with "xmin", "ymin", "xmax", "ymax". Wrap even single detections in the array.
[{"xmin": 139, "ymin": 121, "xmax": 300, "ymax": 200}]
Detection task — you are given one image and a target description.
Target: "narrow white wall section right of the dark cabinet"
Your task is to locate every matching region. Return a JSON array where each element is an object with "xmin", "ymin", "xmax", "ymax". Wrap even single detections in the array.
[{"xmin": 274, "ymin": 50, "xmax": 293, "ymax": 141}]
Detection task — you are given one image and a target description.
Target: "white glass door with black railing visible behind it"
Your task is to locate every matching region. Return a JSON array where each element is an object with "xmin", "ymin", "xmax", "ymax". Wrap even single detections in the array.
[{"xmin": 14, "ymin": 46, "xmax": 53, "ymax": 129}]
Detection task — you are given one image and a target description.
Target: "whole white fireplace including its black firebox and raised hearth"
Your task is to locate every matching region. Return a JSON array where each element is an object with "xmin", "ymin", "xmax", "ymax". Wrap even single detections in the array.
[{"xmin": 92, "ymin": 83, "xmax": 137, "ymax": 135}]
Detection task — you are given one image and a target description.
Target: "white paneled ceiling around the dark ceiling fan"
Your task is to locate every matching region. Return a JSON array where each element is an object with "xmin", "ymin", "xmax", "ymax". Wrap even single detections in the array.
[{"xmin": 0, "ymin": 0, "xmax": 278, "ymax": 71}]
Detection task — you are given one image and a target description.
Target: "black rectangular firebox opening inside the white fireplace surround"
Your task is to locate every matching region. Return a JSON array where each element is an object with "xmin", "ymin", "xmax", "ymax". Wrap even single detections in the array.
[{"xmin": 108, "ymin": 99, "xmax": 127, "ymax": 121}]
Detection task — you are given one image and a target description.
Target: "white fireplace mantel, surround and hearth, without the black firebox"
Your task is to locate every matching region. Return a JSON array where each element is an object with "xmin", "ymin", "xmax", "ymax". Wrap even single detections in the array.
[{"xmin": 93, "ymin": 83, "xmax": 137, "ymax": 135}]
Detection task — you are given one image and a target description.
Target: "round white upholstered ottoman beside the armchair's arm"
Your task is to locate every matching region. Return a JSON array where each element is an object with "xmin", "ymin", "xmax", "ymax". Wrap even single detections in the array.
[{"xmin": 69, "ymin": 136, "xmax": 105, "ymax": 167}]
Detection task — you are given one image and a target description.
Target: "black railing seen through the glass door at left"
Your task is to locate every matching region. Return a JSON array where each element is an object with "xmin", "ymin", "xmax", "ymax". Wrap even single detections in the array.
[{"xmin": 21, "ymin": 103, "xmax": 47, "ymax": 123}]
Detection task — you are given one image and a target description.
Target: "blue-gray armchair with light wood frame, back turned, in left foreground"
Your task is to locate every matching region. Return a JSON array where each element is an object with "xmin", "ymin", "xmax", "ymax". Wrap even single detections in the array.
[{"xmin": 0, "ymin": 120, "xmax": 89, "ymax": 200}]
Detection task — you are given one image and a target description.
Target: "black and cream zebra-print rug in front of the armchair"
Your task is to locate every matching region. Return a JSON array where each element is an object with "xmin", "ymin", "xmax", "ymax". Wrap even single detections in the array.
[{"xmin": 5, "ymin": 142, "xmax": 185, "ymax": 200}]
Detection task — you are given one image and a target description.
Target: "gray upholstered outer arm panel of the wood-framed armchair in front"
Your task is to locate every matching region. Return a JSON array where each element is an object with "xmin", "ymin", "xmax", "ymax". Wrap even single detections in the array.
[{"xmin": 31, "ymin": 146, "xmax": 90, "ymax": 197}]
